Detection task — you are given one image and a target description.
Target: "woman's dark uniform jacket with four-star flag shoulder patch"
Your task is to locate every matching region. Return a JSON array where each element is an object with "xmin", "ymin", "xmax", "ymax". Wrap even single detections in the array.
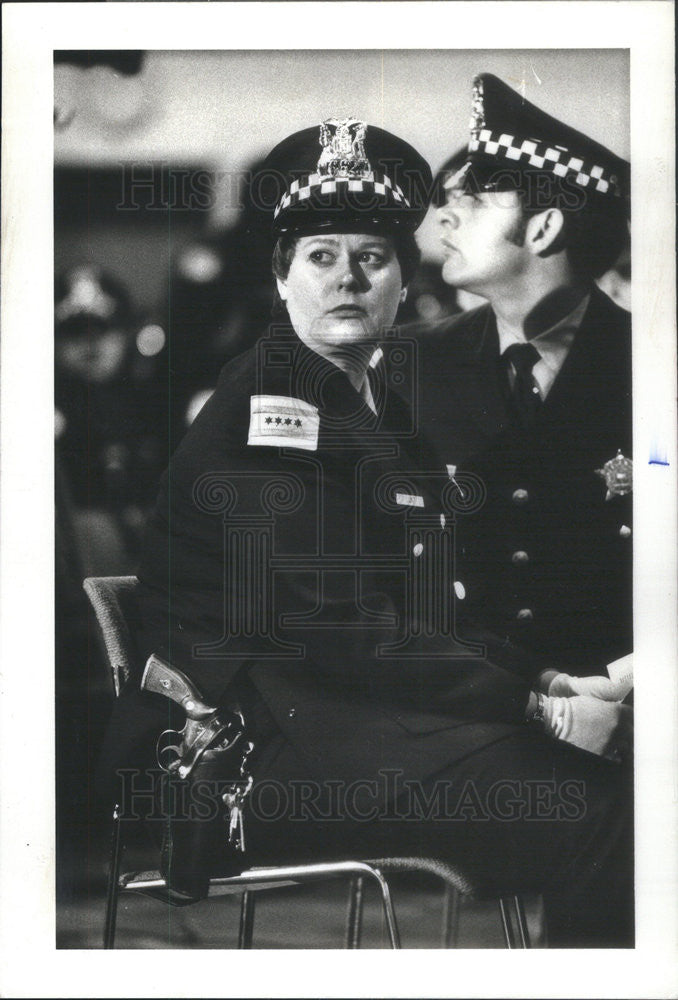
[{"xmin": 126, "ymin": 330, "xmax": 530, "ymax": 804}]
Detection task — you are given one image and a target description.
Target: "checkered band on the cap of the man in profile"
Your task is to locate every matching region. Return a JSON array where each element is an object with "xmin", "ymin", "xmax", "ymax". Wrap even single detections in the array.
[{"xmin": 468, "ymin": 128, "xmax": 621, "ymax": 197}]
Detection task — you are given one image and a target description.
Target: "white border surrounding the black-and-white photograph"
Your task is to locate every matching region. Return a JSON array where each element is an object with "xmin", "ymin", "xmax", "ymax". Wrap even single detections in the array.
[{"xmin": 0, "ymin": 0, "xmax": 678, "ymax": 997}]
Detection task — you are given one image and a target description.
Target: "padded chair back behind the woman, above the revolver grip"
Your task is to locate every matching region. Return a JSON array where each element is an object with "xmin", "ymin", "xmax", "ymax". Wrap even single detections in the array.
[{"xmin": 82, "ymin": 576, "xmax": 139, "ymax": 698}]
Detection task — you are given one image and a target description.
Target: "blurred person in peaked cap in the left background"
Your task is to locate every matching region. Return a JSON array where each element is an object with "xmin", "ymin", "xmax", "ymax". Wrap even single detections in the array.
[{"xmin": 55, "ymin": 265, "xmax": 167, "ymax": 574}]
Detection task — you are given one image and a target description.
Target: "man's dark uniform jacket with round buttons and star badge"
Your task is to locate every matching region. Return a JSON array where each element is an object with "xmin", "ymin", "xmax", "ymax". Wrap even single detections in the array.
[{"xmin": 412, "ymin": 290, "xmax": 632, "ymax": 673}]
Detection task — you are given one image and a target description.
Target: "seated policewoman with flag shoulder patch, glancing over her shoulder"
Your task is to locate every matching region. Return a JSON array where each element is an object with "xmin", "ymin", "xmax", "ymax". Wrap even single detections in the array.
[{"xmin": 103, "ymin": 119, "xmax": 633, "ymax": 946}]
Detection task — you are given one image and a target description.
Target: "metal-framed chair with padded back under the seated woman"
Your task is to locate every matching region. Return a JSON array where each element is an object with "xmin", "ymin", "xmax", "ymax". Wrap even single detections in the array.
[{"xmin": 83, "ymin": 576, "xmax": 530, "ymax": 948}]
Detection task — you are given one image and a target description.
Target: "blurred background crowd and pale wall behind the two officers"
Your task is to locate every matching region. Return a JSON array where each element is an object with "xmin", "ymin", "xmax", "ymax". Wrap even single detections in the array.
[{"xmin": 54, "ymin": 50, "xmax": 630, "ymax": 916}]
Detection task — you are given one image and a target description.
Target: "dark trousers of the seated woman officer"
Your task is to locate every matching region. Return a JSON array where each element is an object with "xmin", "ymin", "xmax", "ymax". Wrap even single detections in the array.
[{"xmin": 247, "ymin": 727, "xmax": 634, "ymax": 948}]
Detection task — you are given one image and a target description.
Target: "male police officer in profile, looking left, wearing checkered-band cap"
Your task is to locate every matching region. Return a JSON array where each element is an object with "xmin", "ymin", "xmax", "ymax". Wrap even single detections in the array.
[{"xmin": 412, "ymin": 74, "xmax": 632, "ymax": 700}]
